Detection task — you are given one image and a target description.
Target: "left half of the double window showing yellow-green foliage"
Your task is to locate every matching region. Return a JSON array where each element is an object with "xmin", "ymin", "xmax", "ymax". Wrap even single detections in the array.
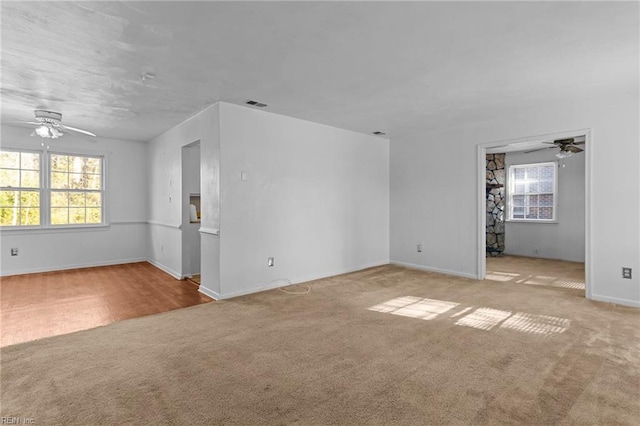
[{"xmin": 0, "ymin": 150, "xmax": 41, "ymax": 226}]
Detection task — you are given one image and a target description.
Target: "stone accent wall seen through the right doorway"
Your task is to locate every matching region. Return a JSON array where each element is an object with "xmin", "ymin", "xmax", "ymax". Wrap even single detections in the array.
[{"xmin": 486, "ymin": 154, "xmax": 506, "ymax": 256}]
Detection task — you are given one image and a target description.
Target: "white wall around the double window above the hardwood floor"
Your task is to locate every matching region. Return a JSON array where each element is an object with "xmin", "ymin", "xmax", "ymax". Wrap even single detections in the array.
[{"xmin": 0, "ymin": 125, "xmax": 147, "ymax": 275}]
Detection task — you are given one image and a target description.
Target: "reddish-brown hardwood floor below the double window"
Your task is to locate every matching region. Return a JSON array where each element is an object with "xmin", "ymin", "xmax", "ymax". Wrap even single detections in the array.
[{"xmin": 0, "ymin": 262, "xmax": 212, "ymax": 346}]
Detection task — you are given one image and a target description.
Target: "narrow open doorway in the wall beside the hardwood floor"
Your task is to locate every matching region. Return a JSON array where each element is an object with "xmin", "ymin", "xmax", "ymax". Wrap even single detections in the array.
[{"xmin": 182, "ymin": 140, "xmax": 201, "ymax": 283}]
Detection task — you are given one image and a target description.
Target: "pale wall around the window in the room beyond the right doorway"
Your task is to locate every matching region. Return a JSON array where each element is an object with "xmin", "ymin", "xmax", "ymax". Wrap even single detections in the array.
[{"xmin": 505, "ymin": 149, "xmax": 586, "ymax": 262}]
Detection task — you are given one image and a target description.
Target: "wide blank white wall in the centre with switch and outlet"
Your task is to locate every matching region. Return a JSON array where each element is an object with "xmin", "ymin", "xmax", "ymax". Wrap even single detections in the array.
[{"xmin": 215, "ymin": 103, "xmax": 389, "ymax": 297}]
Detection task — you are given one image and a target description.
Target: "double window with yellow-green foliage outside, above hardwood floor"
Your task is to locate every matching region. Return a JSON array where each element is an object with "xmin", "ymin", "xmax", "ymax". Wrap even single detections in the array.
[{"xmin": 0, "ymin": 149, "xmax": 104, "ymax": 228}]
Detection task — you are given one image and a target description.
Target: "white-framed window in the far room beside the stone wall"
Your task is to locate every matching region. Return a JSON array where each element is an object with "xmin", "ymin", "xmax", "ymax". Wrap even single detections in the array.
[{"xmin": 508, "ymin": 162, "xmax": 557, "ymax": 221}]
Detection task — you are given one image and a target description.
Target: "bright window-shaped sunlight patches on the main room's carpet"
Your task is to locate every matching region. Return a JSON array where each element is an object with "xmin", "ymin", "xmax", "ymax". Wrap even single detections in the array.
[{"xmin": 368, "ymin": 296, "xmax": 571, "ymax": 336}]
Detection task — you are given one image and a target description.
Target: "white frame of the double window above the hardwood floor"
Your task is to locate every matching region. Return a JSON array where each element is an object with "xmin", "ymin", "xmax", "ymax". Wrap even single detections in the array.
[{"xmin": 0, "ymin": 146, "xmax": 110, "ymax": 233}]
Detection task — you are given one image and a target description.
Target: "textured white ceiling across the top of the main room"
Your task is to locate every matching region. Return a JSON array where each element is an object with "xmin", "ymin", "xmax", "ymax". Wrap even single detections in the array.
[{"xmin": 1, "ymin": 1, "xmax": 639, "ymax": 141}]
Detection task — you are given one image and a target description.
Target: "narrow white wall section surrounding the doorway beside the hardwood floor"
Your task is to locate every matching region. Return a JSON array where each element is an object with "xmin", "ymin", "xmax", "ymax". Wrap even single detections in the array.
[{"xmin": 148, "ymin": 104, "xmax": 219, "ymax": 282}]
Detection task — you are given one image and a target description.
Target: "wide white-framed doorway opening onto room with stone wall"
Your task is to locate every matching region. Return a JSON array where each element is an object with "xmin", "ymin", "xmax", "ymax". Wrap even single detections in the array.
[{"xmin": 478, "ymin": 130, "xmax": 591, "ymax": 297}]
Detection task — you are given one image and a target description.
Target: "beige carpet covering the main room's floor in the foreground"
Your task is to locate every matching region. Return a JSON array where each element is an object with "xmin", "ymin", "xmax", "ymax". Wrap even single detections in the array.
[{"xmin": 1, "ymin": 266, "xmax": 640, "ymax": 425}]
